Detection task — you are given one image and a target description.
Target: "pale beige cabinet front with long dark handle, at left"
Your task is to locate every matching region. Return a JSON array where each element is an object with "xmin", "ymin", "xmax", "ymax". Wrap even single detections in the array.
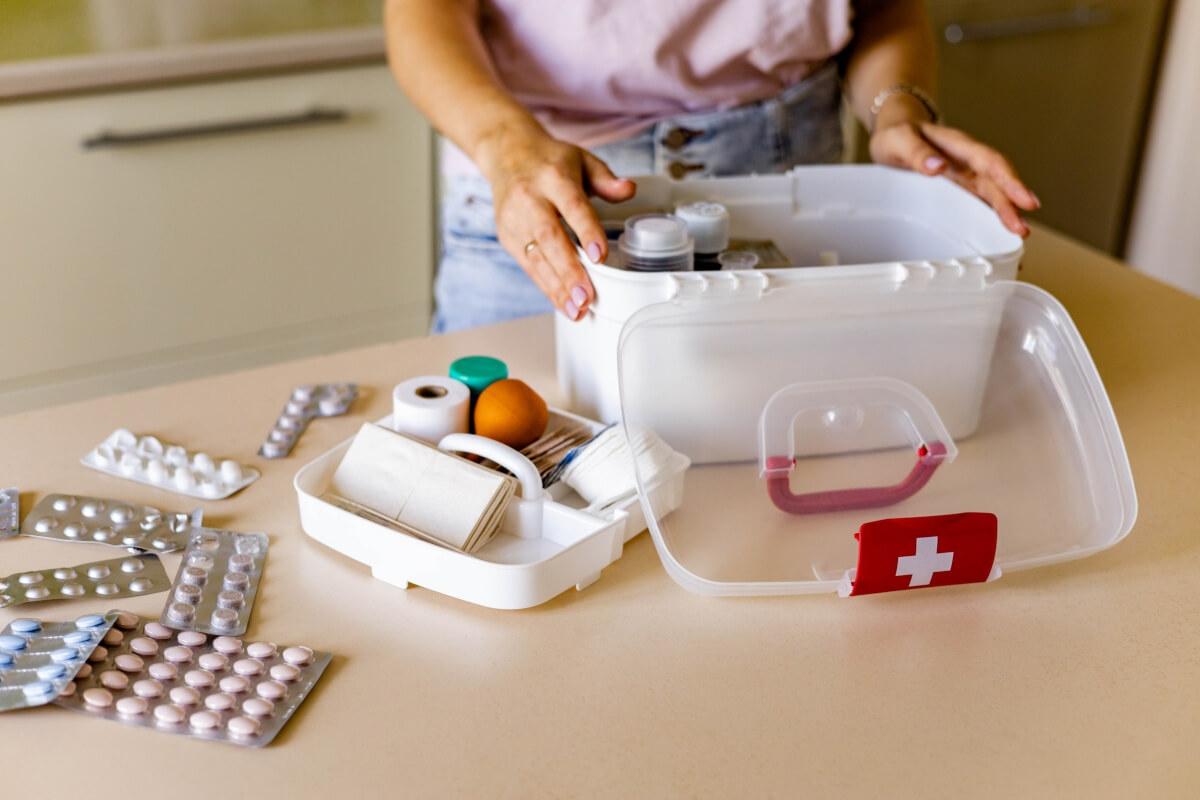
[{"xmin": 0, "ymin": 64, "xmax": 433, "ymax": 411}]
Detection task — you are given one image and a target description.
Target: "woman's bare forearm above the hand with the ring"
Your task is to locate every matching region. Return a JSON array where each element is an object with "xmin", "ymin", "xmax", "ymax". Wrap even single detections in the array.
[{"xmin": 384, "ymin": 0, "xmax": 541, "ymax": 166}]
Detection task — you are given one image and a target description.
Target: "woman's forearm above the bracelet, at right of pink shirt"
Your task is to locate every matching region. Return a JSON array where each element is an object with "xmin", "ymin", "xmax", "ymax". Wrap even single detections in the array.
[{"xmin": 846, "ymin": 0, "xmax": 937, "ymax": 130}]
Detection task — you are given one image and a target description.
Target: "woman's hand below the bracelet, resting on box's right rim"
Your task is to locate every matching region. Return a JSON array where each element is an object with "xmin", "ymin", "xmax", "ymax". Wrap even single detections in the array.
[{"xmin": 870, "ymin": 96, "xmax": 1042, "ymax": 236}]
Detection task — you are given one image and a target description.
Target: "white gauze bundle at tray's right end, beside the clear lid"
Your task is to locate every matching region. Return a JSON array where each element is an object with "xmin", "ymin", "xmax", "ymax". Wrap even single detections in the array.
[{"xmin": 562, "ymin": 426, "xmax": 676, "ymax": 509}]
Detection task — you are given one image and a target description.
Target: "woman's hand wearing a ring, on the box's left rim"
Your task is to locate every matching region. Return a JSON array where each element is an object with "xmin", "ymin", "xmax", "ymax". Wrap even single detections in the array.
[{"xmin": 475, "ymin": 126, "xmax": 636, "ymax": 320}]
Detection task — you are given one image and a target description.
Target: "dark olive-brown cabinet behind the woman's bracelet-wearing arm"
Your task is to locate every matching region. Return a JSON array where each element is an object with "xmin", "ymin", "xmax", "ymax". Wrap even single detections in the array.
[{"xmin": 929, "ymin": 0, "xmax": 1166, "ymax": 253}]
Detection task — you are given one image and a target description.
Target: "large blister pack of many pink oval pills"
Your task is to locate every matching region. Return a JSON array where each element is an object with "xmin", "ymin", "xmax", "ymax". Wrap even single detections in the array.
[{"xmin": 56, "ymin": 615, "xmax": 331, "ymax": 747}]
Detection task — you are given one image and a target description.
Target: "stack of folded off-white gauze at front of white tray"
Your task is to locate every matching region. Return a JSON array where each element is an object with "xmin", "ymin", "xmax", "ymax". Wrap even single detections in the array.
[{"xmin": 329, "ymin": 422, "xmax": 517, "ymax": 553}]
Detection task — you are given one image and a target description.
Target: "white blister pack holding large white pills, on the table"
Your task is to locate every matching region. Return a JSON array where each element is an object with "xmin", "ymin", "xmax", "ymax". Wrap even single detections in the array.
[{"xmin": 82, "ymin": 428, "xmax": 259, "ymax": 500}]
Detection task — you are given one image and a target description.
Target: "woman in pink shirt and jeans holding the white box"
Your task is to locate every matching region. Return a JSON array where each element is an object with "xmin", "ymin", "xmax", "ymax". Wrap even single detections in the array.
[{"xmin": 386, "ymin": 0, "xmax": 1039, "ymax": 331}]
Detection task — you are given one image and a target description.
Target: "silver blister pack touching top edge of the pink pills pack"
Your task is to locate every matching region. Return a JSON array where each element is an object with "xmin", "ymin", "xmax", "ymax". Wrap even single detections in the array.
[{"xmin": 158, "ymin": 528, "xmax": 268, "ymax": 636}]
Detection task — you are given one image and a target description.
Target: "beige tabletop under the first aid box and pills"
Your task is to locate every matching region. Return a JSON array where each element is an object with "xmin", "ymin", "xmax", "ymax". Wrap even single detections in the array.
[{"xmin": 0, "ymin": 230, "xmax": 1200, "ymax": 798}]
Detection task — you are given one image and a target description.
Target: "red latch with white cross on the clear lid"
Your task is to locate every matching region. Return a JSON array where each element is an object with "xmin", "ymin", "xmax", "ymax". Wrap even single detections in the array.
[{"xmin": 848, "ymin": 512, "xmax": 996, "ymax": 596}]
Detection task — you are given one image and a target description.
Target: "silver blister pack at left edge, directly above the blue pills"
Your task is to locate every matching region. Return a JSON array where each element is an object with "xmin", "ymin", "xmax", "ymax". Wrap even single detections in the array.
[{"xmin": 0, "ymin": 553, "xmax": 170, "ymax": 608}]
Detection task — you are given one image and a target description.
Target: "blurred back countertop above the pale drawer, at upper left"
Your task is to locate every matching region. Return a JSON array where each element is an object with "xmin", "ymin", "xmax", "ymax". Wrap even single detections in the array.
[{"xmin": 0, "ymin": 0, "xmax": 384, "ymax": 101}]
